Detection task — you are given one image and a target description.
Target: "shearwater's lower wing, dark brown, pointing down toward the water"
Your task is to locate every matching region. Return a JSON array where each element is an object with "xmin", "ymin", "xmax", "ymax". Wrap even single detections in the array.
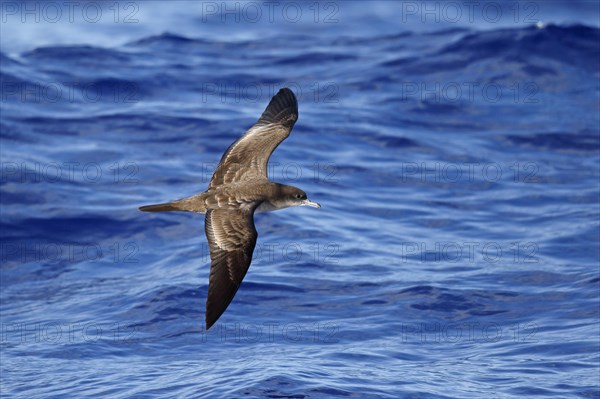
[{"xmin": 204, "ymin": 208, "xmax": 258, "ymax": 330}]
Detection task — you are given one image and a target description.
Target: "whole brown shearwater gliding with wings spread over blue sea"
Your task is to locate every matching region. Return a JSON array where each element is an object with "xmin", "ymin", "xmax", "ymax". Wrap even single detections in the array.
[{"xmin": 139, "ymin": 88, "xmax": 321, "ymax": 330}]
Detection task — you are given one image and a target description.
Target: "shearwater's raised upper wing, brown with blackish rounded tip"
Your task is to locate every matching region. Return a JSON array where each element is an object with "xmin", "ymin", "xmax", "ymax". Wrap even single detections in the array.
[{"xmin": 209, "ymin": 88, "xmax": 298, "ymax": 189}]
